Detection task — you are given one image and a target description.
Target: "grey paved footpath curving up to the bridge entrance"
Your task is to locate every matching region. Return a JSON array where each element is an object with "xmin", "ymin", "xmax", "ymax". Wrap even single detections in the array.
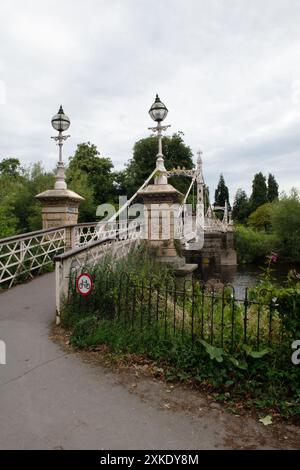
[{"xmin": 0, "ymin": 273, "xmax": 300, "ymax": 449}]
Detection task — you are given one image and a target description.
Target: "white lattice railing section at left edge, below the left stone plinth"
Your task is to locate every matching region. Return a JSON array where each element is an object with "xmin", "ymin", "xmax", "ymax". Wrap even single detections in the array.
[{"xmin": 0, "ymin": 227, "xmax": 66, "ymax": 288}]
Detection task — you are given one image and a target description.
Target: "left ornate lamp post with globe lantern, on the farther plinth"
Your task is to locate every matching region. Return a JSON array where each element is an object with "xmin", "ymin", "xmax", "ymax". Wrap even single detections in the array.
[{"xmin": 51, "ymin": 106, "xmax": 70, "ymax": 189}]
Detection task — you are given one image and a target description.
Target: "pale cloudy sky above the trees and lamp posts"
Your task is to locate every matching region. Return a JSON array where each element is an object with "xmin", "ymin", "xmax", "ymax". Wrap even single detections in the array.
[{"xmin": 0, "ymin": 0, "xmax": 300, "ymax": 200}]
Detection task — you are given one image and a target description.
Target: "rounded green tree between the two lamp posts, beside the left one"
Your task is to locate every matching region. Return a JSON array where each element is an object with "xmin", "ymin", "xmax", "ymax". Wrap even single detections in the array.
[{"xmin": 67, "ymin": 142, "xmax": 115, "ymax": 210}]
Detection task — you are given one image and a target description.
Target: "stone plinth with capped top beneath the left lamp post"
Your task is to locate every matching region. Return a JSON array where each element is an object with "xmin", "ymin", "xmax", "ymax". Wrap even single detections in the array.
[{"xmin": 35, "ymin": 189, "xmax": 84, "ymax": 229}]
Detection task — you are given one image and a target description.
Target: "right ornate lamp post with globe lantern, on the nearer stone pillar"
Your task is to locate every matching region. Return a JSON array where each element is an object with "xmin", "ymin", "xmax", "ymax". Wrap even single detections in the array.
[{"xmin": 149, "ymin": 95, "xmax": 170, "ymax": 184}]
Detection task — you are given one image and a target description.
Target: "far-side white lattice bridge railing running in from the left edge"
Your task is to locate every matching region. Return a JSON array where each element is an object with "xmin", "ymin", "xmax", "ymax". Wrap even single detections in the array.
[{"xmin": 0, "ymin": 221, "xmax": 143, "ymax": 289}]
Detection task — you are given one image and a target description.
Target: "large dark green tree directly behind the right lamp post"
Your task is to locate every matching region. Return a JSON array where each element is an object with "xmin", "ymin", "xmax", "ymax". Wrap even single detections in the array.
[{"xmin": 124, "ymin": 132, "xmax": 194, "ymax": 195}]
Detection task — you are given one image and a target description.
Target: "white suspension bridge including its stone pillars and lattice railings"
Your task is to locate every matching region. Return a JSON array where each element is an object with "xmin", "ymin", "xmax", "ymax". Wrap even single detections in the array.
[{"xmin": 0, "ymin": 152, "xmax": 236, "ymax": 320}]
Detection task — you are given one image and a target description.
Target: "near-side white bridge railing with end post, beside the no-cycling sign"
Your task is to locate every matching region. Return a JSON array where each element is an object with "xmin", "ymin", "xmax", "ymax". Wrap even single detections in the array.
[{"xmin": 54, "ymin": 223, "xmax": 143, "ymax": 324}]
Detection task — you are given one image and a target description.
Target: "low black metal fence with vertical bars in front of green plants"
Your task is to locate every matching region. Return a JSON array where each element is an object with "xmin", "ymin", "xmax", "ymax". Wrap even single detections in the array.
[{"xmin": 69, "ymin": 272, "xmax": 287, "ymax": 351}]
